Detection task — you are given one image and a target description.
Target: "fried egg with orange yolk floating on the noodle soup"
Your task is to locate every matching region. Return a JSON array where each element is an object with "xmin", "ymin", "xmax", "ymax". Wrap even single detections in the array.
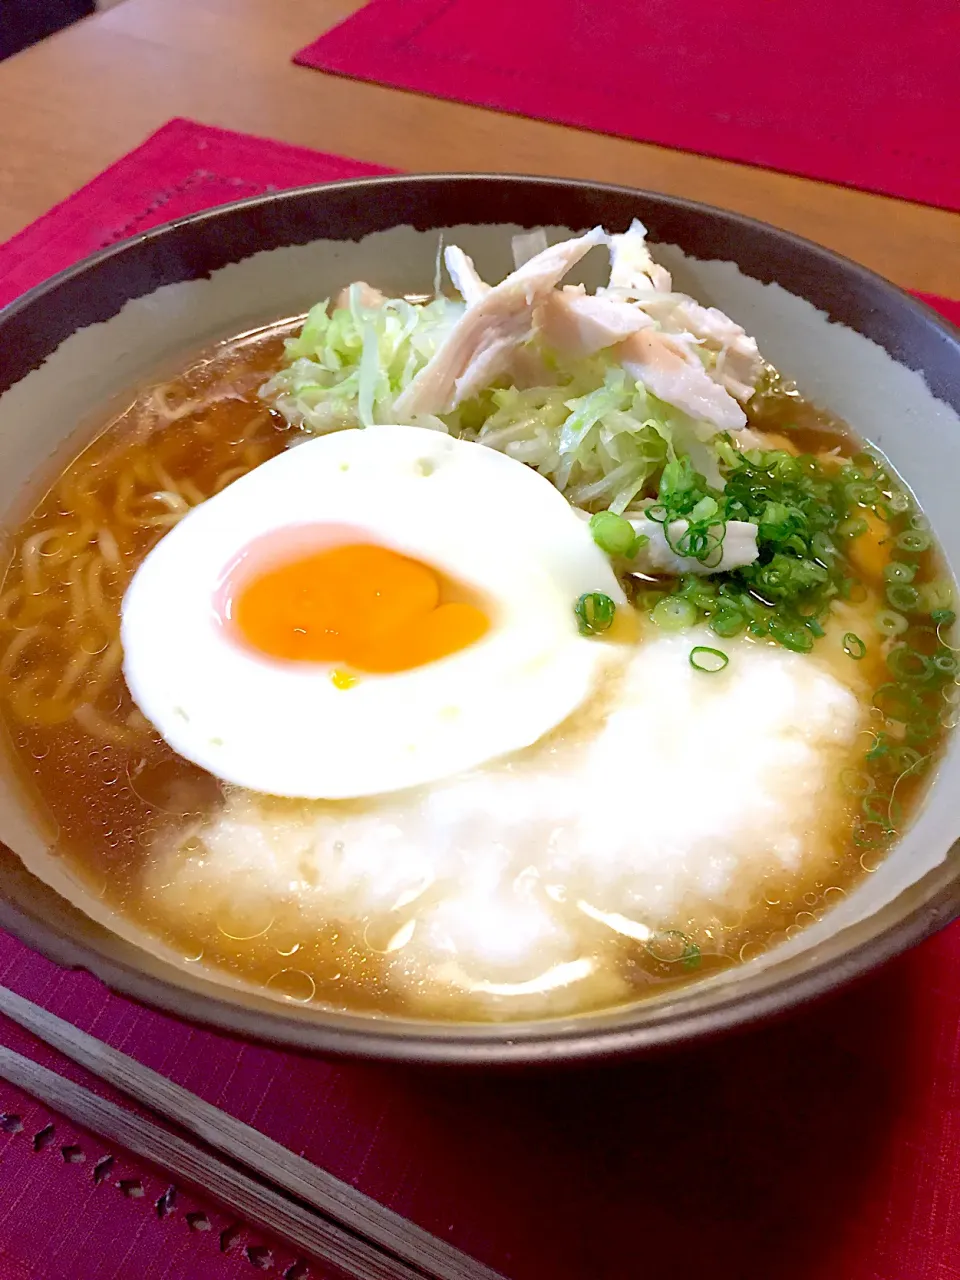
[{"xmin": 122, "ymin": 426, "xmax": 625, "ymax": 799}]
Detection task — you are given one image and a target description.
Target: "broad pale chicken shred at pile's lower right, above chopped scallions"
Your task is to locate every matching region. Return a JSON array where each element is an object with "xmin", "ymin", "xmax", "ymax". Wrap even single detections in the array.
[{"xmin": 613, "ymin": 329, "xmax": 746, "ymax": 431}]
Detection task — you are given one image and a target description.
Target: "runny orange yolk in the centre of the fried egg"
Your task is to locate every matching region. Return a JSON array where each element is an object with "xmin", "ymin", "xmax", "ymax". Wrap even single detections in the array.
[{"xmin": 230, "ymin": 543, "xmax": 490, "ymax": 672}]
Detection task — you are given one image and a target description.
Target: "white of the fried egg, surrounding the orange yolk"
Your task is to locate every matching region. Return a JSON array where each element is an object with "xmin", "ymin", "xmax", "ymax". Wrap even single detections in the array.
[{"xmin": 122, "ymin": 426, "xmax": 623, "ymax": 799}]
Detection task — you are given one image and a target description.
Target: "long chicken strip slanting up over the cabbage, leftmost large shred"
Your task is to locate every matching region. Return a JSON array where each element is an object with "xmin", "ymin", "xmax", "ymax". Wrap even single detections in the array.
[{"xmin": 394, "ymin": 227, "xmax": 607, "ymax": 421}]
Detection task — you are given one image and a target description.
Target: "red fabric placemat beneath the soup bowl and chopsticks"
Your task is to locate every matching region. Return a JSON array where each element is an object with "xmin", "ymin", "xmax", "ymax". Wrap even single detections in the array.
[{"xmin": 0, "ymin": 120, "xmax": 960, "ymax": 1280}]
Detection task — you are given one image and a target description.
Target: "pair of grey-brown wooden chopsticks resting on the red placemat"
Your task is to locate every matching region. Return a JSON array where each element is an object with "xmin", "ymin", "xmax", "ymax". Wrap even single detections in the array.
[{"xmin": 0, "ymin": 987, "xmax": 512, "ymax": 1280}]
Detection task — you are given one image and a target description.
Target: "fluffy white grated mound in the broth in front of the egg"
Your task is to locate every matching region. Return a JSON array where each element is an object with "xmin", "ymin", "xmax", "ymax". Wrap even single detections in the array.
[{"xmin": 147, "ymin": 631, "xmax": 864, "ymax": 1012}]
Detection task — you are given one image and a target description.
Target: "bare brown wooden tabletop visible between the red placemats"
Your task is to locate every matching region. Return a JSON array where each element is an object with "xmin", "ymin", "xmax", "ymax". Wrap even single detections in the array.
[{"xmin": 0, "ymin": 0, "xmax": 960, "ymax": 298}]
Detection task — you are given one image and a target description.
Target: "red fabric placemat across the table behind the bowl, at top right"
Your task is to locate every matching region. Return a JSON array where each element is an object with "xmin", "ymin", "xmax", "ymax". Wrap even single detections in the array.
[{"xmin": 296, "ymin": 0, "xmax": 960, "ymax": 209}]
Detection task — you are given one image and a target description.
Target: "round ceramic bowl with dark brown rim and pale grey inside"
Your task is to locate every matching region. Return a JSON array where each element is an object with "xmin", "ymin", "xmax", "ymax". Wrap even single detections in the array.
[{"xmin": 0, "ymin": 177, "xmax": 960, "ymax": 1064}]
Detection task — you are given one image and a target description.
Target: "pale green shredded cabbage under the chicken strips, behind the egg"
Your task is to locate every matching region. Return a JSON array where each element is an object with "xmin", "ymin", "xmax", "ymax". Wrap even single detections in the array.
[{"xmin": 260, "ymin": 285, "xmax": 723, "ymax": 513}]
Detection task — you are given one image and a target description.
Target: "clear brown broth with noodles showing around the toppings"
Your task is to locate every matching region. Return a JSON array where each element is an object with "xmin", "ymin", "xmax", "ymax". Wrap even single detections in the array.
[{"xmin": 0, "ymin": 325, "xmax": 960, "ymax": 1019}]
